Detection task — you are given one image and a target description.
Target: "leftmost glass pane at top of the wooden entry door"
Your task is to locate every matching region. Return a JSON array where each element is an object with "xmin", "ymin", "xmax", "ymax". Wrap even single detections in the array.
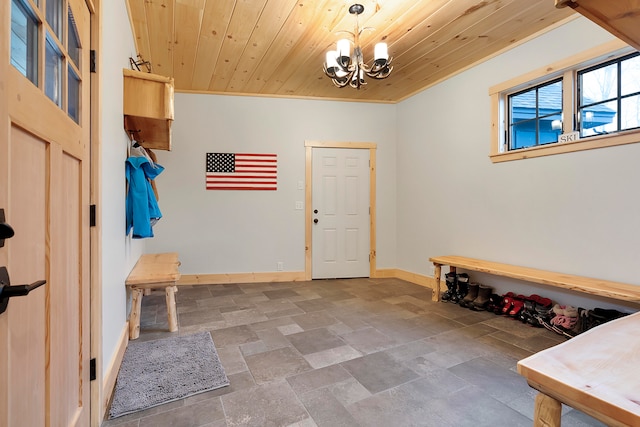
[{"xmin": 11, "ymin": 0, "xmax": 38, "ymax": 85}]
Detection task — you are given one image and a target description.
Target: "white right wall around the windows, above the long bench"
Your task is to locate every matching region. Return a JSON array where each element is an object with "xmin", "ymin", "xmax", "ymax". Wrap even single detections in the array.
[{"xmin": 397, "ymin": 18, "xmax": 640, "ymax": 310}]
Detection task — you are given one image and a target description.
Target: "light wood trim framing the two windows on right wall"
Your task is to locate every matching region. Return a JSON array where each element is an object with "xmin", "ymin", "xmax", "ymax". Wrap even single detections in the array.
[{"xmin": 489, "ymin": 39, "xmax": 640, "ymax": 163}]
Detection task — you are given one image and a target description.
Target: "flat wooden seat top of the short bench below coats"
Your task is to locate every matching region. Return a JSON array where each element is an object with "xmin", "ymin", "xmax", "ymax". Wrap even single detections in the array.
[{"xmin": 125, "ymin": 252, "xmax": 180, "ymax": 286}]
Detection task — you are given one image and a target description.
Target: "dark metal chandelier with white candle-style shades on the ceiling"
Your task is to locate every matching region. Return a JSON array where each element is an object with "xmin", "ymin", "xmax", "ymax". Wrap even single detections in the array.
[{"xmin": 323, "ymin": 4, "xmax": 393, "ymax": 89}]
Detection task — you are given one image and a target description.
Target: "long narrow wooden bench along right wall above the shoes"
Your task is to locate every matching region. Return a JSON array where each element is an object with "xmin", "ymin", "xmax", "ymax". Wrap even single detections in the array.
[{"xmin": 429, "ymin": 255, "xmax": 640, "ymax": 303}]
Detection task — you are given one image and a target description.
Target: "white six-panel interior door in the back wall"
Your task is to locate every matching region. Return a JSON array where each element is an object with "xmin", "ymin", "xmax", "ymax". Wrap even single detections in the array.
[{"xmin": 311, "ymin": 148, "xmax": 370, "ymax": 279}]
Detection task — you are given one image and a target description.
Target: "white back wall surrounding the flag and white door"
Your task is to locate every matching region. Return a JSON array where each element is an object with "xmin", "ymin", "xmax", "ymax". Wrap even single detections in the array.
[{"xmin": 147, "ymin": 93, "xmax": 396, "ymax": 274}]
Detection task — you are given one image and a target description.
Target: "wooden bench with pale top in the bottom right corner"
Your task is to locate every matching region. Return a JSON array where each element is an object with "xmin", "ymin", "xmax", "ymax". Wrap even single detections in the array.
[{"xmin": 518, "ymin": 312, "xmax": 640, "ymax": 427}]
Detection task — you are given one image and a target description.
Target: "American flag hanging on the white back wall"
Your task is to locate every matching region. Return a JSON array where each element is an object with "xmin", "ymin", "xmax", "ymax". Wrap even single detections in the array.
[{"xmin": 206, "ymin": 153, "xmax": 278, "ymax": 190}]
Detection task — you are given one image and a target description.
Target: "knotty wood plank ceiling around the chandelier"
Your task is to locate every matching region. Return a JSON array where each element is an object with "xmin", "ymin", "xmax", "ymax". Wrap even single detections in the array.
[{"xmin": 127, "ymin": 0, "xmax": 574, "ymax": 103}]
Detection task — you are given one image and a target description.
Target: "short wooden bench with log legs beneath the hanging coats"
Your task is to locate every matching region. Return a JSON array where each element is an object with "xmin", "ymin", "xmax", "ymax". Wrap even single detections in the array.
[{"xmin": 125, "ymin": 252, "xmax": 180, "ymax": 340}]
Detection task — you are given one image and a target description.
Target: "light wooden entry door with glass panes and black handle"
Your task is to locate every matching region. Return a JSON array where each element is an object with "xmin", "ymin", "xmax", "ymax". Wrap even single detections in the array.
[{"xmin": 0, "ymin": 0, "xmax": 91, "ymax": 427}]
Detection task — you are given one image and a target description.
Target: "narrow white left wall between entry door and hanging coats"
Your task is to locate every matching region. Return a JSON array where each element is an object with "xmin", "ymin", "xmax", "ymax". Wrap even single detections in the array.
[{"xmin": 98, "ymin": 1, "xmax": 144, "ymax": 374}]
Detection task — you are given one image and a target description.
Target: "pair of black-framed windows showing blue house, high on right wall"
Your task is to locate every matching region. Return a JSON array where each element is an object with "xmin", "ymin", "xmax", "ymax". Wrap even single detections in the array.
[{"xmin": 494, "ymin": 52, "xmax": 640, "ymax": 154}]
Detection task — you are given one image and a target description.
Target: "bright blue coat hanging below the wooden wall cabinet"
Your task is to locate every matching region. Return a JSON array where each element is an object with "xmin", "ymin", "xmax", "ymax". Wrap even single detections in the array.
[{"xmin": 125, "ymin": 156, "xmax": 164, "ymax": 239}]
